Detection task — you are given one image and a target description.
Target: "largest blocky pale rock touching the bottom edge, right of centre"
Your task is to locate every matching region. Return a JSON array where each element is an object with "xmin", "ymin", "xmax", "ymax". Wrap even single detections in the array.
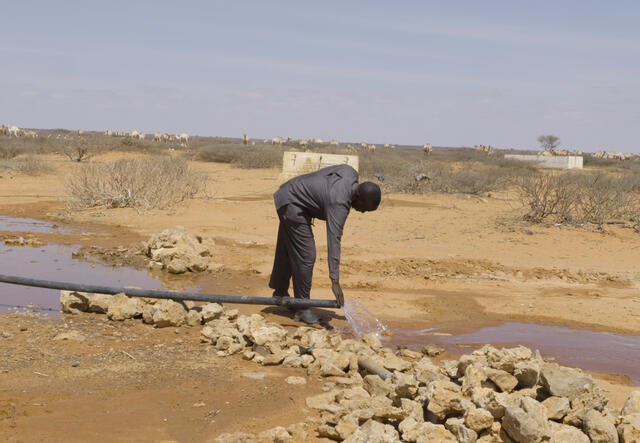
[{"xmin": 502, "ymin": 397, "xmax": 550, "ymax": 443}]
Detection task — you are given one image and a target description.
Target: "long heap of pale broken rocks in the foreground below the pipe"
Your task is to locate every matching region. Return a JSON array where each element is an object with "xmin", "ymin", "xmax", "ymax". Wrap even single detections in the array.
[{"xmin": 61, "ymin": 292, "xmax": 640, "ymax": 443}]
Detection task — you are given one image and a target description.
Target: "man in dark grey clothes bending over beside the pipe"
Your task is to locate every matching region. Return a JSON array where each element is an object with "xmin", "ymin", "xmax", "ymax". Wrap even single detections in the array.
[{"xmin": 269, "ymin": 165, "xmax": 381, "ymax": 324}]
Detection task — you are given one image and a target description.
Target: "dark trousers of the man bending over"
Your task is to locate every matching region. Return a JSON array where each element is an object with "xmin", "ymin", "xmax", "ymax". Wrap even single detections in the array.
[{"xmin": 269, "ymin": 205, "xmax": 316, "ymax": 298}]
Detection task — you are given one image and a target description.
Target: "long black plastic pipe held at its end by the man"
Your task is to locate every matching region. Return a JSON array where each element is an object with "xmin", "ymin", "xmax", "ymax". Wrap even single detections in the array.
[{"xmin": 0, "ymin": 274, "xmax": 339, "ymax": 308}]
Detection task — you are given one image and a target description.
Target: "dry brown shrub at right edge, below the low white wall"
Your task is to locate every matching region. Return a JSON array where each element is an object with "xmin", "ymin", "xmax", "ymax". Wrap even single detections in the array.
[{"xmin": 516, "ymin": 173, "xmax": 640, "ymax": 226}]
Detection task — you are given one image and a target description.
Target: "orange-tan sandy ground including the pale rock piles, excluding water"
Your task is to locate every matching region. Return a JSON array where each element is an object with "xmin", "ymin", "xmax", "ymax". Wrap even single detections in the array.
[{"xmin": 0, "ymin": 153, "xmax": 640, "ymax": 441}]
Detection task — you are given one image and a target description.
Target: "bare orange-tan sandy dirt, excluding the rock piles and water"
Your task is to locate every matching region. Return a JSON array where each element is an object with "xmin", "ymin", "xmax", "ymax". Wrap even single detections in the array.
[{"xmin": 0, "ymin": 153, "xmax": 640, "ymax": 441}]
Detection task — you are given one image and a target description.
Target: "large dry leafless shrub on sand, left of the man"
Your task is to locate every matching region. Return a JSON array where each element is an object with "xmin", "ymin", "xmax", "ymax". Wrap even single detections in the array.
[{"xmin": 65, "ymin": 157, "xmax": 207, "ymax": 209}]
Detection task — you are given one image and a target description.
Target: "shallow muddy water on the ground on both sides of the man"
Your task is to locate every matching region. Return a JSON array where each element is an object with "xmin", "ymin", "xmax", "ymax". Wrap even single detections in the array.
[{"xmin": 0, "ymin": 216, "xmax": 640, "ymax": 384}]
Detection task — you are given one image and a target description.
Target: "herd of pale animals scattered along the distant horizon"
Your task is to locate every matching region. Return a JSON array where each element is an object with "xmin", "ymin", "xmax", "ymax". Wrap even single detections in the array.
[{"xmin": 0, "ymin": 125, "xmax": 640, "ymax": 160}]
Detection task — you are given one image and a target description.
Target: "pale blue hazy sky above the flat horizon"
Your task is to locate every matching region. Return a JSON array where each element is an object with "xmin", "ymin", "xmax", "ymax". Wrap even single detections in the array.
[{"xmin": 0, "ymin": 0, "xmax": 640, "ymax": 152}]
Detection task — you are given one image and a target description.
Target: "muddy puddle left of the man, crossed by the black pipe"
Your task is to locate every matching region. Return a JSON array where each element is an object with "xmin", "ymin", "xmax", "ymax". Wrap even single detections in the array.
[{"xmin": 0, "ymin": 244, "xmax": 199, "ymax": 317}]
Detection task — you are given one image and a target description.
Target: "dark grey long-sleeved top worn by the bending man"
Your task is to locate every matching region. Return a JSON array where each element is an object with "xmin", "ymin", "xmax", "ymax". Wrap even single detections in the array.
[{"xmin": 273, "ymin": 165, "xmax": 358, "ymax": 280}]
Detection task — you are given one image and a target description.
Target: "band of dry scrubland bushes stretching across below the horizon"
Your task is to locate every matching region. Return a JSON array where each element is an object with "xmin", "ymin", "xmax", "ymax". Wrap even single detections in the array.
[{"xmin": 0, "ymin": 130, "xmax": 640, "ymax": 227}]
